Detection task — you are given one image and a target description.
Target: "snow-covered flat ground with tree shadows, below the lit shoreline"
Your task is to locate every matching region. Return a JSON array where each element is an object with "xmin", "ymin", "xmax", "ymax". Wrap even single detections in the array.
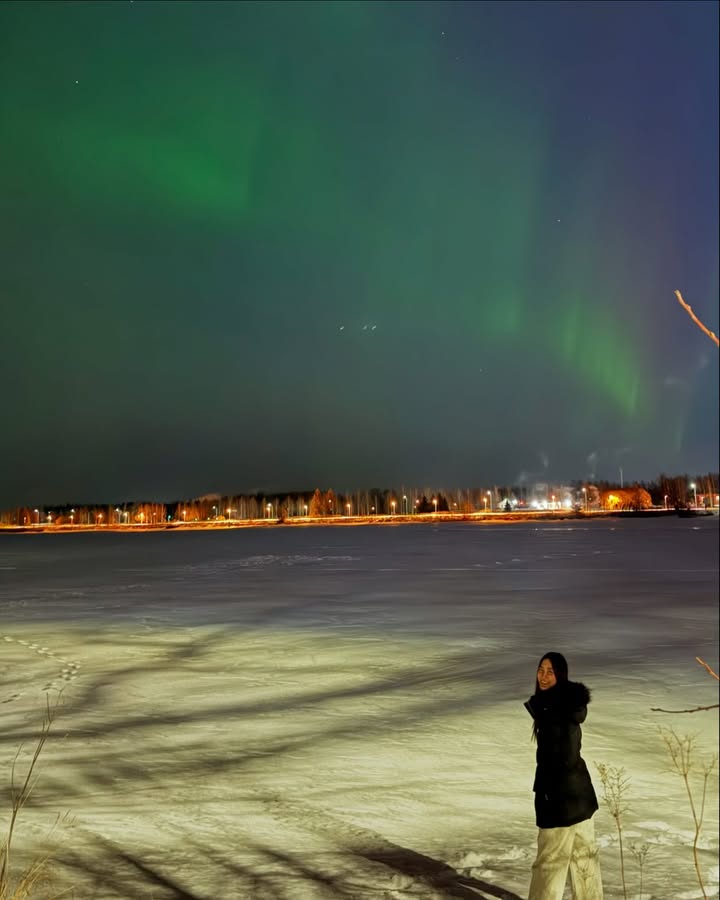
[{"xmin": 0, "ymin": 517, "xmax": 718, "ymax": 900}]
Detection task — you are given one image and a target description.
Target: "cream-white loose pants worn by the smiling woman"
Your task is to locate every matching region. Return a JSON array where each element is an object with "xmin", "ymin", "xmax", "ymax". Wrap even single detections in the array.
[{"xmin": 528, "ymin": 819, "xmax": 602, "ymax": 900}]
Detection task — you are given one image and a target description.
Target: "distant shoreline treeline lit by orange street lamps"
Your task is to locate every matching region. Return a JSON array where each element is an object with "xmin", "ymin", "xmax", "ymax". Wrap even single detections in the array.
[{"xmin": 0, "ymin": 472, "xmax": 720, "ymax": 526}]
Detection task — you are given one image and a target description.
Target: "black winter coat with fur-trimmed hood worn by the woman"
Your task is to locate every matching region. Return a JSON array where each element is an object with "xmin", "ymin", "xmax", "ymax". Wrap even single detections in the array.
[{"xmin": 525, "ymin": 681, "xmax": 598, "ymax": 828}]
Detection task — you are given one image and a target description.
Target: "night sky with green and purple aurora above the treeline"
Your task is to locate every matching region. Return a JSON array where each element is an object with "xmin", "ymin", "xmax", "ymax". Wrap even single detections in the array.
[{"xmin": 0, "ymin": 0, "xmax": 718, "ymax": 507}]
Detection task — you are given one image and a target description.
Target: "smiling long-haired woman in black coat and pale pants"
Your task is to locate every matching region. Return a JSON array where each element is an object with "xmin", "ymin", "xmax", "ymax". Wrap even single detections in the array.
[{"xmin": 525, "ymin": 653, "xmax": 603, "ymax": 900}]
